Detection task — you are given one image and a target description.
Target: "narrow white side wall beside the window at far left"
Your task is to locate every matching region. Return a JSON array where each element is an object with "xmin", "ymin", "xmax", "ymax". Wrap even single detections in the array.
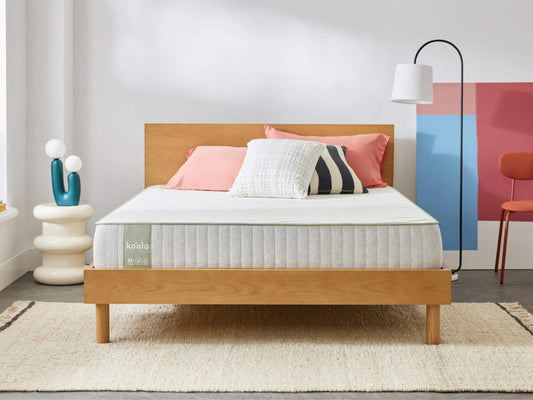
[{"xmin": 0, "ymin": 0, "xmax": 28, "ymax": 290}]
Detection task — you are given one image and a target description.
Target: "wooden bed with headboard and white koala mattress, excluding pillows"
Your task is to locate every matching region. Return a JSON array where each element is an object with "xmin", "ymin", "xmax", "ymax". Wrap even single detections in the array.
[{"xmin": 85, "ymin": 124, "xmax": 451, "ymax": 344}]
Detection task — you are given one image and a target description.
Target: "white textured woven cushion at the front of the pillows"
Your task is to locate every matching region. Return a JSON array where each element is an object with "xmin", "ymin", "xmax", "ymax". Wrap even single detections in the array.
[{"xmin": 230, "ymin": 139, "xmax": 326, "ymax": 199}]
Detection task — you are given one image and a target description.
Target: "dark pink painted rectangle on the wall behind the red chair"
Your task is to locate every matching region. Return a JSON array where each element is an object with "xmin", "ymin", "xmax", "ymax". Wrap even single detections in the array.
[{"xmin": 476, "ymin": 83, "xmax": 533, "ymax": 221}]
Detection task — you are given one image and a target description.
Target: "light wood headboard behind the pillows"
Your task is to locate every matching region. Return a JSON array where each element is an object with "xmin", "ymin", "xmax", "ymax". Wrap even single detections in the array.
[{"xmin": 144, "ymin": 124, "xmax": 394, "ymax": 187}]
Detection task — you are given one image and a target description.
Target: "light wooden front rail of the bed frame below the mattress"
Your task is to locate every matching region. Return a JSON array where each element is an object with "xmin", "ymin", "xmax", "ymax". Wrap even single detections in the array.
[{"xmin": 85, "ymin": 269, "xmax": 451, "ymax": 304}]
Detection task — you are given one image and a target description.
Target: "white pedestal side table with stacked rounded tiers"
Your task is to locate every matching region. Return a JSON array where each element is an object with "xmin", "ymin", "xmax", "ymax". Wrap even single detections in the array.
[{"xmin": 33, "ymin": 203, "xmax": 93, "ymax": 285}]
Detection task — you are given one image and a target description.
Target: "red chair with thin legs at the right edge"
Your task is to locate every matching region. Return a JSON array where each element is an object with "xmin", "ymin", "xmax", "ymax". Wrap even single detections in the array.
[{"xmin": 494, "ymin": 153, "xmax": 533, "ymax": 284}]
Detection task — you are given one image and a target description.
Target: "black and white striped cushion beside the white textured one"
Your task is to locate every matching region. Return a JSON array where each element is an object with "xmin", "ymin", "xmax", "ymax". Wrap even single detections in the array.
[{"xmin": 308, "ymin": 146, "xmax": 368, "ymax": 194}]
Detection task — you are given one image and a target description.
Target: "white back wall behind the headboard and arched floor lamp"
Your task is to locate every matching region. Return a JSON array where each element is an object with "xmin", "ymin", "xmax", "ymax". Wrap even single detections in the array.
[{"xmin": 14, "ymin": 0, "xmax": 533, "ymax": 276}]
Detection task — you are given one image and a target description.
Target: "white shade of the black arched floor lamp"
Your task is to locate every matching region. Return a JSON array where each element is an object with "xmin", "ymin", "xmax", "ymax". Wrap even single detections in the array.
[{"xmin": 391, "ymin": 64, "xmax": 433, "ymax": 104}]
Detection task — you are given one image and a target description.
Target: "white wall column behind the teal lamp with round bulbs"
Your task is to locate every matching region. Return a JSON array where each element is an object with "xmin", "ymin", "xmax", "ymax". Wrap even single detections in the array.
[{"xmin": 26, "ymin": 0, "xmax": 74, "ymax": 269}]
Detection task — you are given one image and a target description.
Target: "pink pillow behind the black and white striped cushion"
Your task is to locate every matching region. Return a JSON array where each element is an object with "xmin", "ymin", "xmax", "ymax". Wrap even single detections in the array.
[{"xmin": 265, "ymin": 125, "xmax": 390, "ymax": 188}]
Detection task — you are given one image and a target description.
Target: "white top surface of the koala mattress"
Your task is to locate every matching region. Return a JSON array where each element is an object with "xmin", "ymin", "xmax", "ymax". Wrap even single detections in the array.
[{"xmin": 96, "ymin": 186, "xmax": 438, "ymax": 225}]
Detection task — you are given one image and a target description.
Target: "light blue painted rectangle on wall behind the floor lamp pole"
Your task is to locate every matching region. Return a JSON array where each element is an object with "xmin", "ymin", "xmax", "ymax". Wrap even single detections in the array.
[{"xmin": 416, "ymin": 115, "xmax": 478, "ymax": 250}]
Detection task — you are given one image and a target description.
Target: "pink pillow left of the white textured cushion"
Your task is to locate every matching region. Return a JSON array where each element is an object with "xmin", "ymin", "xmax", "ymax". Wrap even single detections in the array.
[{"xmin": 162, "ymin": 146, "xmax": 246, "ymax": 192}]
